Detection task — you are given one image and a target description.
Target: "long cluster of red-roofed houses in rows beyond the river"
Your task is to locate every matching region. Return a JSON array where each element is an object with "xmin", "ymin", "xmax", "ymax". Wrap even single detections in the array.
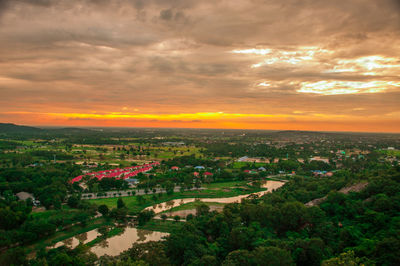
[{"xmin": 71, "ymin": 162, "xmax": 160, "ymax": 183}]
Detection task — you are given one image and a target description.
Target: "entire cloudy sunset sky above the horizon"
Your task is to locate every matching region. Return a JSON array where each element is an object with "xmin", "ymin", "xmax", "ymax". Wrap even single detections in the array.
[{"xmin": 0, "ymin": 0, "xmax": 400, "ymax": 132}]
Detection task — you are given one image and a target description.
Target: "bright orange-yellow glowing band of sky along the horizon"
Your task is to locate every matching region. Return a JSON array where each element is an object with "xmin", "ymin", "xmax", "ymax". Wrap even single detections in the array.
[{"xmin": 3, "ymin": 110, "xmax": 400, "ymax": 133}]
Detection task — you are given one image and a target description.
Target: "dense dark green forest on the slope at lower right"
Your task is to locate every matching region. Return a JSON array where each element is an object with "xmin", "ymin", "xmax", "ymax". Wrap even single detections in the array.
[{"xmin": 100, "ymin": 167, "xmax": 400, "ymax": 266}]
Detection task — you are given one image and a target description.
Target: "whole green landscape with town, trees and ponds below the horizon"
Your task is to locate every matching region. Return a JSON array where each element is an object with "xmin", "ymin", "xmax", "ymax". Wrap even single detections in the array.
[{"xmin": 0, "ymin": 124, "xmax": 400, "ymax": 265}]
